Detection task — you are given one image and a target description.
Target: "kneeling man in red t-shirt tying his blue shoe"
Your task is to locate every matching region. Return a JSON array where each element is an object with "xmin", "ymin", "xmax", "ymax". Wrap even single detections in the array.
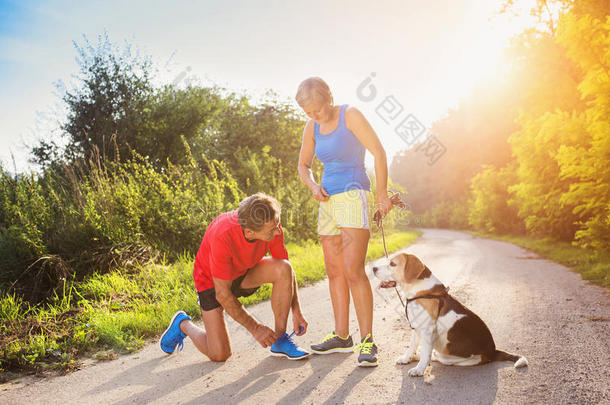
[{"xmin": 159, "ymin": 193, "xmax": 309, "ymax": 361}]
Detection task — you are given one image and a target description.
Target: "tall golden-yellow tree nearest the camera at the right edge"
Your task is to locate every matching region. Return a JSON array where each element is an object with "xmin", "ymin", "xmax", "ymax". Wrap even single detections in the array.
[{"xmin": 510, "ymin": 0, "xmax": 610, "ymax": 241}]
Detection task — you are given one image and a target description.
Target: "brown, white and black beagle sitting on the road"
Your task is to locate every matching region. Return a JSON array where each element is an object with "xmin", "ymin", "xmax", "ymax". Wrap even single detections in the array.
[{"xmin": 373, "ymin": 253, "xmax": 527, "ymax": 377}]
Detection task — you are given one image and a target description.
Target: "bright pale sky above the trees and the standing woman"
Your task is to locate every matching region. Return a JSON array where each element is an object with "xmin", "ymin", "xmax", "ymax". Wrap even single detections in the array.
[{"xmin": 0, "ymin": 0, "xmax": 531, "ymax": 171}]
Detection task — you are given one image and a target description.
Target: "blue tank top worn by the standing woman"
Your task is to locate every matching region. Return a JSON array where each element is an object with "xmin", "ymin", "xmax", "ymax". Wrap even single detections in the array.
[{"xmin": 314, "ymin": 104, "xmax": 371, "ymax": 195}]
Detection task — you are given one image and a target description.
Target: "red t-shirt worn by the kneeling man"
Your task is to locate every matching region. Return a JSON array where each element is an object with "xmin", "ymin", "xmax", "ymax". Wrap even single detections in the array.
[{"xmin": 193, "ymin": 210, "xmax": 288, "ymax": 291}]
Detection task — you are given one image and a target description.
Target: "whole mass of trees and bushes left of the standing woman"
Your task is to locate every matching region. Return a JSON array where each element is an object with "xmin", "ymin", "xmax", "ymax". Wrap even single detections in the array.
[{"xmin": 0, "ymin": 34, "xmax": 320, "ymax": 302}]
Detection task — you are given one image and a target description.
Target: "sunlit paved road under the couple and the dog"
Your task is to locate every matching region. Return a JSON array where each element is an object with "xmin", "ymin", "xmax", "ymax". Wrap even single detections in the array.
[{"xmin": 0, "ymin": 229, "xmax": 610, "ymax": 405}]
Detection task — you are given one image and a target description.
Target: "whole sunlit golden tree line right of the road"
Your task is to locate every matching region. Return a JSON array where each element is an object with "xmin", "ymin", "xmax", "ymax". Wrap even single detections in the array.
[{"xmin": 391, "ymin": 0, "xmax": 610, "ymax": 250}]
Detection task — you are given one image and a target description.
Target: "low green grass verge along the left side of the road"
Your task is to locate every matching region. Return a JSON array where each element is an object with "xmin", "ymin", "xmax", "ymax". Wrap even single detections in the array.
[{"xmin": 0, "ymin": 231, "xmax": 420, "ymax": 381}]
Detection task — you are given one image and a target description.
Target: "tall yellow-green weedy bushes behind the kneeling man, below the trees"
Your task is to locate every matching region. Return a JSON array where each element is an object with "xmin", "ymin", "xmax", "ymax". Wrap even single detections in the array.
[{"xmin": 0, "ymin": 152, "xmax": 243, "ymax": 302}]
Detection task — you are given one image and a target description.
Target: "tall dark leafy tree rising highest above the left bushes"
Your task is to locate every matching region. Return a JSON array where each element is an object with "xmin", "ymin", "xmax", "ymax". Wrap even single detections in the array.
[{"xmin": 56, "ymin": 33, "xmax": 154, "ymax": 160}]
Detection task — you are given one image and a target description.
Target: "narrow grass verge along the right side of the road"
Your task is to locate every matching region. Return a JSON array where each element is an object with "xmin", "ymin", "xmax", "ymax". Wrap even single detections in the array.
[{"xmin": 468, "ymin": 231, "xmax": 610, "ymax": 288}]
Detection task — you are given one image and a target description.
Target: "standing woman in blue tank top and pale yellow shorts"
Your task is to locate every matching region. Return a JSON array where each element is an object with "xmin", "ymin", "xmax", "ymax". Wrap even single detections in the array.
[{"xmin": 296, "ymin": 77, "xmax": 392, "ymax": 367}]
